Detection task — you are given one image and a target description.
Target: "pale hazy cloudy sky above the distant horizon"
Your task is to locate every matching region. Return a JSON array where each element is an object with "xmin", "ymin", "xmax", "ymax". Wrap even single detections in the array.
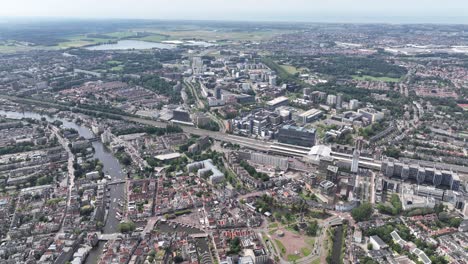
[{"xmin": 0, "ymin": 0, "xmax": 468, "ymax": 23}]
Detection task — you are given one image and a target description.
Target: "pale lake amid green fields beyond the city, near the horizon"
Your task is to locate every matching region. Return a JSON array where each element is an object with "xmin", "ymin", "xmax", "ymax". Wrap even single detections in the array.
[{"xmin": 86, "ymin": 40, "xmax": 176, "ymax": 50}]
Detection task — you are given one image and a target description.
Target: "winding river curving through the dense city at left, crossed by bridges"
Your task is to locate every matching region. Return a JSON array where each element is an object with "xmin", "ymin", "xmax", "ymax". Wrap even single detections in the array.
[{"xmin": 0, "ymin": 110, "xmax": 126, "ymax": 264}]
